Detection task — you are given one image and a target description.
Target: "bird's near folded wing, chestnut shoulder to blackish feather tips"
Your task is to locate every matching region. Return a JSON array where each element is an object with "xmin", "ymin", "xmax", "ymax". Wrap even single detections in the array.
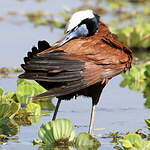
[{"xmin": 19, "ymin": 50, "xmax": 130, "ymax": 98}]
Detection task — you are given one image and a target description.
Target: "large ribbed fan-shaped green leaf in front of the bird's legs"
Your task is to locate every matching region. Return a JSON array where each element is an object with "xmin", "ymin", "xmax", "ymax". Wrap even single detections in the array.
[{"xmin": 39, "ymin": 119, "xmax": 76, "ymax": 146}]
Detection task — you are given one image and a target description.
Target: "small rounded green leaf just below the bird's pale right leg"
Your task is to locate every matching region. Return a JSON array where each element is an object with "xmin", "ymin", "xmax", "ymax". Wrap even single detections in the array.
[{"xmin": 75, "ymin": 132, "xmax": 101, "ymax": 148}]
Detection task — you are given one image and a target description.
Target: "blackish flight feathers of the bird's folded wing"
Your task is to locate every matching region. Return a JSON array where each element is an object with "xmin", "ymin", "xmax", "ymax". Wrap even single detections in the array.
[{"xmin": 19, "ymin": 50, "xmax": 99, "ymax": 98}]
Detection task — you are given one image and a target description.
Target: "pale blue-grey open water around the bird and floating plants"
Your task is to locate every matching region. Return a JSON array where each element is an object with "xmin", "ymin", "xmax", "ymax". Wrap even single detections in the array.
[{"xmin": 0, "ymin": 0, "xmax": 150, "ymax": 150}]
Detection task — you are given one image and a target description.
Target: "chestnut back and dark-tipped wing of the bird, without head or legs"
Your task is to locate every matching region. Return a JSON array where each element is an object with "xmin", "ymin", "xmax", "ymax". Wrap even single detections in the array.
[{"xmin": 20, "ymin": 23, "xmax": 132, "ymax": 98}]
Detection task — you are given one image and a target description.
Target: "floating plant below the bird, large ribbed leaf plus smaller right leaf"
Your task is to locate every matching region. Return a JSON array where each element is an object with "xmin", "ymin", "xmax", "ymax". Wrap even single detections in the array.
[{"xmin": 34, "ymin": 119, "xmax": 100, "ymax": 148}]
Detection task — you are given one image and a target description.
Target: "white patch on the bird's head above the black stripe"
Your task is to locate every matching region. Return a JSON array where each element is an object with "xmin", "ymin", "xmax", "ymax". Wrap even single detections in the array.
[{"xmin": 67, "ymin": 10, "xmax": 95, "ymax": 32}]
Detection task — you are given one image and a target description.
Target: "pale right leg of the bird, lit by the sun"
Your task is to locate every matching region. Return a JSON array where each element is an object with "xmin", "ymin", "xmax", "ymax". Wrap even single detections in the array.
[{"xmin": 89, "ymin": 102, "xmax": 96, "ymax": 135}]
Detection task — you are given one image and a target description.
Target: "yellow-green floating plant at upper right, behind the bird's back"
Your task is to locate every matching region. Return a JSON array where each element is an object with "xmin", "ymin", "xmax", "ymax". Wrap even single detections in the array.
[{"xmin": 114, "ymin": 18, "xmax": 150, "ymax": 49}]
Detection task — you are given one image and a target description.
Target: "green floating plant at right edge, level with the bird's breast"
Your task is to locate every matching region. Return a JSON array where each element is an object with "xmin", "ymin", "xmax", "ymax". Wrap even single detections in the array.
[{"xmin": 120, "ymin": 63, "xmax": 150, "ymax": 108}]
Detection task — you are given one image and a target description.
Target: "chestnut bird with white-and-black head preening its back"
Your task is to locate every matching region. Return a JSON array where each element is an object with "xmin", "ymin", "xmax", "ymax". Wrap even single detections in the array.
[{"xmin": 19, "ymin": 9, "xmax": 133, "ymax": 135}]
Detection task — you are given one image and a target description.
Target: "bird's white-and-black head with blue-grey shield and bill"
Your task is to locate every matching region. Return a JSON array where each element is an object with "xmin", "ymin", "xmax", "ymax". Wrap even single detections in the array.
[{"xmin": 55, "ymin": 10, "xmax": 100, "ymax": 47}]
